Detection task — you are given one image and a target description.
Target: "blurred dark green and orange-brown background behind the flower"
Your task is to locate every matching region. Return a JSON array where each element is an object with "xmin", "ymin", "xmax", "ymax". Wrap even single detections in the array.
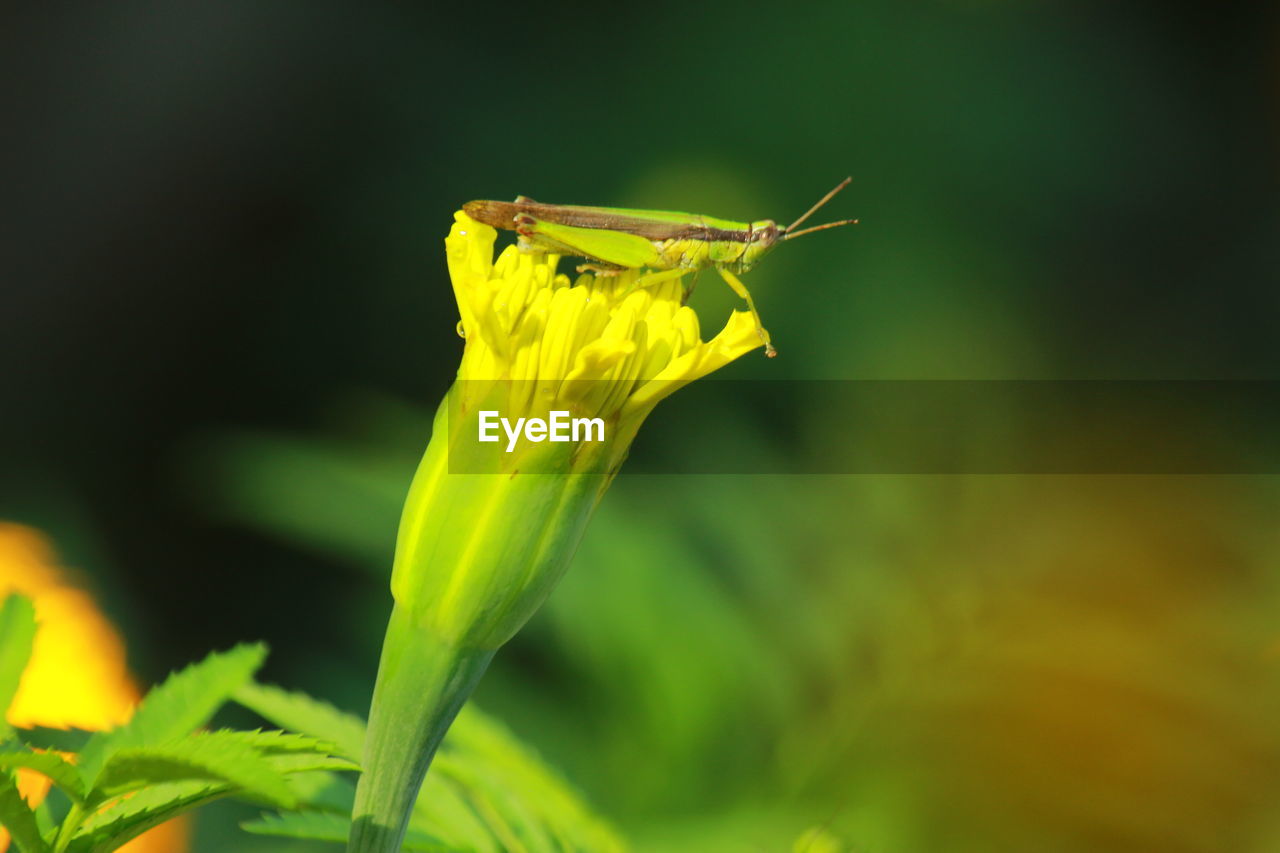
[{"xmin": 0, "ymin": 0, "xmax": 1280, "ymax": 853}]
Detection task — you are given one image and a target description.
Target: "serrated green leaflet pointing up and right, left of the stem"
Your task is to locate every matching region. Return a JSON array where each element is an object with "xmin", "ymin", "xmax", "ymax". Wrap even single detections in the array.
[{"xmin": 79, "ymin": 644, "xmax": 266, "ymax": 781}]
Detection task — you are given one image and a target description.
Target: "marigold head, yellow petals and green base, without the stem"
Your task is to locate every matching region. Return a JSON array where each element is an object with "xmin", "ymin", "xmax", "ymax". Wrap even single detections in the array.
[{"xmin": 392, "ymin": 211, "xmax": 762, "ymax": 649}]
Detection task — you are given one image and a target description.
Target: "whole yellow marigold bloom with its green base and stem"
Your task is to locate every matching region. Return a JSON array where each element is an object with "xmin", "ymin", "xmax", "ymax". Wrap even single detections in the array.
[{"xmin": 348, "ymin": 211, "xmax": 763, "ymax": 853}]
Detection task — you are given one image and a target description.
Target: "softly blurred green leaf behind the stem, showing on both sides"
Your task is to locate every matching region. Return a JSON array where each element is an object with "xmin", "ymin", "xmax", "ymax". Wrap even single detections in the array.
[{"xmin": 236, "ymin": 684, "xmax": 625, "ymax": 853}]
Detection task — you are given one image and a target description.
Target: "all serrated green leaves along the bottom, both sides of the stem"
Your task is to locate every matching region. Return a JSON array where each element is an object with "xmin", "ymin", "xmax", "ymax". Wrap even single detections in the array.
[{"xmin": 0, "ymin": 597, "xmax": 622, "ymax": 853}]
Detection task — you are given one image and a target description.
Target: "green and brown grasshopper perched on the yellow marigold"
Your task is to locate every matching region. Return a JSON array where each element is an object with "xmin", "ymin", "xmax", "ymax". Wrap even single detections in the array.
[{"xmin": 462, "ymin": 178, "xmax": 858, "ymax": 359}]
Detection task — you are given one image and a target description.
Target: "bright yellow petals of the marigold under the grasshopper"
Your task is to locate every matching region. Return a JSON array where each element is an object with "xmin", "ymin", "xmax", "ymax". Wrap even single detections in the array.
[{"xmin": 444, "ymin": 211, "xmax": 762, "ymax": 465}]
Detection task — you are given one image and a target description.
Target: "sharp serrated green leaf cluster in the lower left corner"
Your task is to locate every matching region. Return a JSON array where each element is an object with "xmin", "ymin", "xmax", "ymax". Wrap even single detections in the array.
[{"xmin": 0, "ymin": 635, "xmax": 356, "ymax": 853}]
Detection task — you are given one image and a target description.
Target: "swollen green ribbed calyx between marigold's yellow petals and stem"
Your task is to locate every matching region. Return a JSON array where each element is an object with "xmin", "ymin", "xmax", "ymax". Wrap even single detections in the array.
[{"xmin": 389, "ymin": 389, "xmax": 612, "ymax": 648}]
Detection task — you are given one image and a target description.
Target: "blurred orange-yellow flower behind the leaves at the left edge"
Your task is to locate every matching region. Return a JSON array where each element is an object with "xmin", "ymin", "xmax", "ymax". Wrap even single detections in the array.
[{"xmin": 0, "ymin": 521, "xmax": 187, "ymax": 853}]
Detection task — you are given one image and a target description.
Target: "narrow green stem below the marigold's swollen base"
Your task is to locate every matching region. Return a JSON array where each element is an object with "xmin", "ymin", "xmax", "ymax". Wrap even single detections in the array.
[{"xmin": 347, "ymin": 605, "xmax": 493, "ymax": 853}]
